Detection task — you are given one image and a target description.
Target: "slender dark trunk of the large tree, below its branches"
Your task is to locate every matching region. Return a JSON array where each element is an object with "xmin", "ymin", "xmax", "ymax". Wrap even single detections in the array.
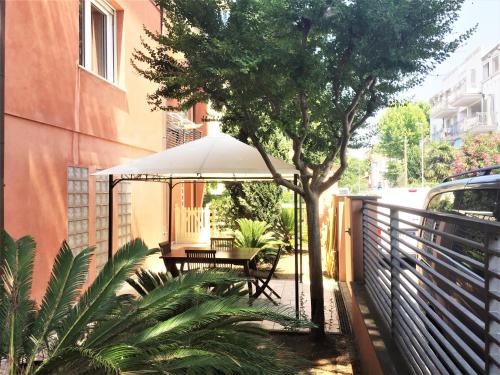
[{"xmin": 304, "ymin": 192, "xmax": 325, "ymax": 340}]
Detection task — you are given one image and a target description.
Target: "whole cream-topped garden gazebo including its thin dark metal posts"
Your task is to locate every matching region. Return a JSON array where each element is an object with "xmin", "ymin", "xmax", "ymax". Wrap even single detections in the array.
[{"xmin": 94, "ymin": 133, "xmax": 302, "ymax": 313}]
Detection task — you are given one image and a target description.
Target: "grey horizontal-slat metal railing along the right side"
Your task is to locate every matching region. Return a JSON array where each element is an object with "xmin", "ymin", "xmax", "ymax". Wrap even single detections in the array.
[{"xmin": 363, "ymin": 200, "xmax": 500, "ymax": 374}]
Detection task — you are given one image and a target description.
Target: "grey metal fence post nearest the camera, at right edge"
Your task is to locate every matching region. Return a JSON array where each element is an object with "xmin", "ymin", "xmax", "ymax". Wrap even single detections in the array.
[{"xmin": 485, "ymin": 234, "xmax": 500, "ymax": 374}]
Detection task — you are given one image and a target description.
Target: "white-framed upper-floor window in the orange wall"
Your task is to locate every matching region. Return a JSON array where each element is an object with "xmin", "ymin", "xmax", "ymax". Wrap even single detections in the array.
[{"xmin": 80, "ymin": 0, "xmax": 116, "ymax": 82}]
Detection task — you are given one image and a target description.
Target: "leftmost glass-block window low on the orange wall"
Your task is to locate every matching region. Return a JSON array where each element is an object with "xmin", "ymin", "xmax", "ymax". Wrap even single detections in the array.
[{"xmin": 68, "ymin": 167, "xmax": 89, "ymax": 254}]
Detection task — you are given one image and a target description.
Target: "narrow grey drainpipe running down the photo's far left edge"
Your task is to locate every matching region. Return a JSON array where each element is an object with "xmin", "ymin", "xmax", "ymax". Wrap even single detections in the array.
[{"xmin": 0, "ymin": 0, "xmax": 5, "ymax": 244}]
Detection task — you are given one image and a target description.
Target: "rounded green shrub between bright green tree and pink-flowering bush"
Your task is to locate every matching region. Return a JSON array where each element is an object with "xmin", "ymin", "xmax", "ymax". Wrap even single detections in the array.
[{"xmin": 424, "ymin": 142, "xmax": 455, "ymax": 184}]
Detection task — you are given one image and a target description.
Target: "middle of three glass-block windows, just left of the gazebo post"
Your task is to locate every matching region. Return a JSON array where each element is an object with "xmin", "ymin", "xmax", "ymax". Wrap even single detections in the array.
[{"xmin": 95, "ymin": 176, "xmax": 109, "ymax": 272}]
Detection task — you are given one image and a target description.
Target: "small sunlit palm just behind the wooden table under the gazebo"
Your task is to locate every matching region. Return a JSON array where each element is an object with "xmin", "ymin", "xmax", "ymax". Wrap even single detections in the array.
[{"xmin": 234, "ymin": 219, "xmax": 281, "ymax": 263}]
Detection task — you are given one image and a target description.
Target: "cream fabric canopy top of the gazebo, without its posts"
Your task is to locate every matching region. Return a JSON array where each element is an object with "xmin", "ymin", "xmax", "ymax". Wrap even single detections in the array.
[{"xmin": 95, "ymin": 133, "xmax": 297, "ymax": 180}]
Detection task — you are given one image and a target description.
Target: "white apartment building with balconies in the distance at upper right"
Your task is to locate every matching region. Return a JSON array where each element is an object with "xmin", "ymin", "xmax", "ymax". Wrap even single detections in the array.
[{"xmin": 430, "ymin": 44, "xmax": 500, "ymax": 147}]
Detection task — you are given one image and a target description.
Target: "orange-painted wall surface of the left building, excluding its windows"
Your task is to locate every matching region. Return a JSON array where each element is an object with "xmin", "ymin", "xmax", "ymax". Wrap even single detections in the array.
[{"xmin": 5, "ymin": 0, "xmax": 202, "ymax": 301}]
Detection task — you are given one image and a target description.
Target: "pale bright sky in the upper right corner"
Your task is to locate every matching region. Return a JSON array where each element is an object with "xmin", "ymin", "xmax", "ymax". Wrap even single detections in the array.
[{"xmin": 408, "ymin": 0, "xmax": 500, "ymax": 101}]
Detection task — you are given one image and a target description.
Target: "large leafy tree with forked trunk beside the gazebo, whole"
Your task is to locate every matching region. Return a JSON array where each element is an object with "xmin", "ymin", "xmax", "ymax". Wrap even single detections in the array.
[{"xmin": 134, "ymin": 0, "xmax": 471, "ymax": 337}]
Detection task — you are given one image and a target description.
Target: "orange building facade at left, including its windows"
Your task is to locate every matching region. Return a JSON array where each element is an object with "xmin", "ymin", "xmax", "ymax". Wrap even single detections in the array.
[{"xmin": 5, "ymin": 0, "xmax": 204, "ymax": 301}]
